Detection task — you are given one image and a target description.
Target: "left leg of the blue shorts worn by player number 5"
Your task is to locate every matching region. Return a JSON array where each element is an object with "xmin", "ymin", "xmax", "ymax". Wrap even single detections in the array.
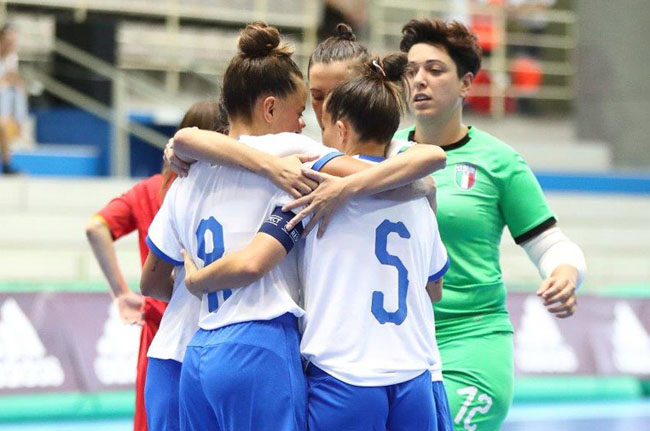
[{"xmin": 307, "ymin": 365, "xmax": 388, "ymax": 431}]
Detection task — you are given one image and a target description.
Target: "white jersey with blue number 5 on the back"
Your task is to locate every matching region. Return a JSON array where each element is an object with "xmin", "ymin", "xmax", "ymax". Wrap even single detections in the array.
[{"xmin": 300, "ymin": 155, "xmax": 449, "ymax": 386}]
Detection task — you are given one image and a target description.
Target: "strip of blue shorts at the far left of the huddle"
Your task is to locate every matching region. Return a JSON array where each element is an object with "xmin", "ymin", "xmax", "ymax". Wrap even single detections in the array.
[{"xmin": 144, "ymin": 358, "xmax": 182, "ymax": 431}]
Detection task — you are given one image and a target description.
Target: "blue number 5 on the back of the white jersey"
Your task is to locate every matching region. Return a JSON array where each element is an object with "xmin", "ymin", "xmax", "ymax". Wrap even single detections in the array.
[{"xmin": 371, "ymin": 220, "xmax": 411, "ymax": 325}]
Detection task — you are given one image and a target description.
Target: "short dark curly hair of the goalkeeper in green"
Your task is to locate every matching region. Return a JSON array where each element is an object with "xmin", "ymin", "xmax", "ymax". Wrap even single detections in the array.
[{"xmin": 399, "ymin": 18, "xmax": 481, "ymax": 78}]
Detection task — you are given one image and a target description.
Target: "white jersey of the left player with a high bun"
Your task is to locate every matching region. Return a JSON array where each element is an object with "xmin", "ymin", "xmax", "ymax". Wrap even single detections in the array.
[{"xmin": 147, "ymin": 133, "xmax": 341, "ymax": 350}]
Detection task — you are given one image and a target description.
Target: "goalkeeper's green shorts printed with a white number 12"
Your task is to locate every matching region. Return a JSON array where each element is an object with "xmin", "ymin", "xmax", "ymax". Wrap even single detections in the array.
[{"xmin": 439, "ymin": 332, "xmax": 514, "ymax": 431}]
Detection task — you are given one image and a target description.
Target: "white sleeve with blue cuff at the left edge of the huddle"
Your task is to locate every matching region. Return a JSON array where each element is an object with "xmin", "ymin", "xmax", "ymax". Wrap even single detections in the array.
[{"xmin": 146, "ymin": 181, "xmax": 183, "ymax": 266}]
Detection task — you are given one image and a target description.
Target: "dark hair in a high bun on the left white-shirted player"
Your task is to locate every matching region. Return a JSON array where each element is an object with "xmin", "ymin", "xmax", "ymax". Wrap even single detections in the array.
[{"xmin": 222, "ymin": 22, "xmax": 302, "ymax": 120}]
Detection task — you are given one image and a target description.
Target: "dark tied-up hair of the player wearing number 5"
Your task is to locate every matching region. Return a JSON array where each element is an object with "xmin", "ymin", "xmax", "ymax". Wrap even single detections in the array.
[{"xmin": 325, "ymin": 53, "xmax": 407, "ymax": 143}]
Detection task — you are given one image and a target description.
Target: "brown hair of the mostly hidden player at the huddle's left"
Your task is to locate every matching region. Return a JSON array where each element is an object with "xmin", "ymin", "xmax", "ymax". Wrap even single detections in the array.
[{"xmin": 160, "ymin": 100, "xmax": 228, "ymax": 197}]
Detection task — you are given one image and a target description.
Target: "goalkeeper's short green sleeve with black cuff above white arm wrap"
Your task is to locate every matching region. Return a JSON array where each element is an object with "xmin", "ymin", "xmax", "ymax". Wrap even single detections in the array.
[{"xmin": 497, "ymin": 153, "xmax": 556, "ymax": 244}]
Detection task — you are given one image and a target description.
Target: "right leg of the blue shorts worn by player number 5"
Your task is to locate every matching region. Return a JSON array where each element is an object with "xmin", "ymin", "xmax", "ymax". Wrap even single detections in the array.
[{"xmin": 386, "ymin": 371, "xmax": 437, "ymax": 431}]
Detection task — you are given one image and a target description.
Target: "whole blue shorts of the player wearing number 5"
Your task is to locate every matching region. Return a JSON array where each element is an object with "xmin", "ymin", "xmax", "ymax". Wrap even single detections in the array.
[{"xmin": 307, "ymin": 364, "xmax": 438, "ymax": 431}]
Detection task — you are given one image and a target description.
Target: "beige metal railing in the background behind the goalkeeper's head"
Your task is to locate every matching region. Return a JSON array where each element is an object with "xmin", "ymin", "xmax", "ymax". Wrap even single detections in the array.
[{"xmin": 370, "ymin": 0, "xmax": 576, "ymax": 118}]
